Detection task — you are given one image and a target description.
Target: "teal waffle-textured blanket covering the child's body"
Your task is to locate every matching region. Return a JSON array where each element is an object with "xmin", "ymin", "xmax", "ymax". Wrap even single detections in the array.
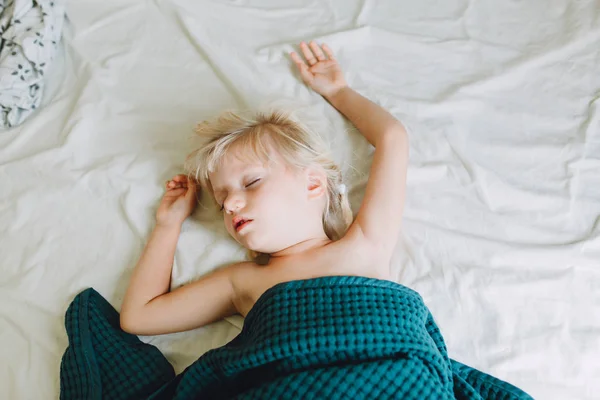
[{"xmin": 60, "ymin": 276, "xmax": 531, "ymax": 400}]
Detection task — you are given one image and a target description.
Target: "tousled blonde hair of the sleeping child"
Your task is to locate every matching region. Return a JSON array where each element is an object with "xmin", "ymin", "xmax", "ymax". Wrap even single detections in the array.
[{"xmin": 185, "ymin": 110, "xmax": 353, "ymax": 258}]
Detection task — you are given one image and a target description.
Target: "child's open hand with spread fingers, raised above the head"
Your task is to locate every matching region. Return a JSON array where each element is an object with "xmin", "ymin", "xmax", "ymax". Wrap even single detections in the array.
[{"xmin": 290, "ymin": 41, "xmax": 348, "ymax": 98}]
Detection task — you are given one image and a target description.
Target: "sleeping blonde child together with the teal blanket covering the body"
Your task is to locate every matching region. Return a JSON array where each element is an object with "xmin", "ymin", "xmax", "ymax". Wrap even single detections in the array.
[{"xmin": 61, "ymin": 41, "xmax": 530, "ymax": 399}]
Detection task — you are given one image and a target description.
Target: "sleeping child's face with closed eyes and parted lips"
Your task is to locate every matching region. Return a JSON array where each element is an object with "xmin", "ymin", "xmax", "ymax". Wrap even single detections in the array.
[{"xmin": 209, "ymin": 142, "xmax": 324, "ymax": 254}]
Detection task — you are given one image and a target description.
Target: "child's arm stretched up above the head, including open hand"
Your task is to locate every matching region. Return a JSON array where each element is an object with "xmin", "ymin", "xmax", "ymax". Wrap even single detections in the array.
[{"xmin": 292, "ymin": 42, "xmax": 409, "ymax": 257}]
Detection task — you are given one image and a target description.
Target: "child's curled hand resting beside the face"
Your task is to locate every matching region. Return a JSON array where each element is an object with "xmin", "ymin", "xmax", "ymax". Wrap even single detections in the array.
[{"xmin": 156, "ymin": 175, "xmax": 197, "ymax": 225}]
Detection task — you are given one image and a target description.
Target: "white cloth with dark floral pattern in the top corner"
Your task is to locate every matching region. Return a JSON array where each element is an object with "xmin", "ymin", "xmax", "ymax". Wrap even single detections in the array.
[{"xmin": 0, "ymin": 0, "xmax": 65, "ymax": 128}]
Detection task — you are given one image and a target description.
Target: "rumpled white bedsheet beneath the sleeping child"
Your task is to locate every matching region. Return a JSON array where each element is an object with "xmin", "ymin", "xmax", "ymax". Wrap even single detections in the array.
[{"xmin": 0, "ymin": 0, "xmax": 600, "ymax": 399}]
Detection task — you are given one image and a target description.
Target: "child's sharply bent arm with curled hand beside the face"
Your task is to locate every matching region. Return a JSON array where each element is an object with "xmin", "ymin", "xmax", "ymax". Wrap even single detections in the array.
[{"xmin": 121, "ymin": 175, "xmax": 236, "ymax": 335}]
